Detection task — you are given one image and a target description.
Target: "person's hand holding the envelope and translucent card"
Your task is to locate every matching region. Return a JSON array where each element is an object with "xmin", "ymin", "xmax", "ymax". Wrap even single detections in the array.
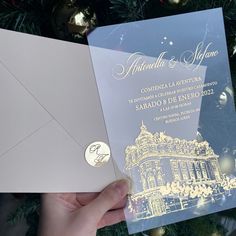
[{"xmin": 39, "ymin": 180, "xmax": 129, "ymax": 236}]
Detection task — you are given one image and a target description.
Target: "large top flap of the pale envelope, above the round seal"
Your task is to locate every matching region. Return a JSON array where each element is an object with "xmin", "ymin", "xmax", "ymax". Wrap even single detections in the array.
[{"xmin": 0, "ymin": 30, "xmax": 107, "ymax": 147}]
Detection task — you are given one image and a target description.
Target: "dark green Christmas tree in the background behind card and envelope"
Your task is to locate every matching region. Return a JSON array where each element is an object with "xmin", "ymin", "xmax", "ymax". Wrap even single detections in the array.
[{"xmin": 0, "ymin": 0, "xmax": 236, "ymax": 236}]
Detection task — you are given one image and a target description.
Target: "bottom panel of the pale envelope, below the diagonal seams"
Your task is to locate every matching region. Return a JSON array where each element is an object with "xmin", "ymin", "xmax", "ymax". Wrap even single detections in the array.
[{"xmin": 0, "ymin": 121, "xmax": 115, "ymax": 192}]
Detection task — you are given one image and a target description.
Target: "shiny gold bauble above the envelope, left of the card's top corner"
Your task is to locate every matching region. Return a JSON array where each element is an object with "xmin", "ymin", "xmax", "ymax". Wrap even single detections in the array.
[{"xmin": 52, "ymin": 0, "xmax": 97, "ymax": 40}]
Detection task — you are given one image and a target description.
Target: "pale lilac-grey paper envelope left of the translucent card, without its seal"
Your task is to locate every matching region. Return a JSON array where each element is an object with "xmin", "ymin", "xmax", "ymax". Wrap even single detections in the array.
[{"xmin": 0, "ymin": 29, "xmax": 116, "ymax": 192}]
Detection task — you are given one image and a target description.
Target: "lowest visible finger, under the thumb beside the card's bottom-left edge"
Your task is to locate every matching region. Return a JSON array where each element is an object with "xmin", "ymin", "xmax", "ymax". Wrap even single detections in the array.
[{"xmin": 98, "ymin": 209, "xmax": 125, "ymax": 229}]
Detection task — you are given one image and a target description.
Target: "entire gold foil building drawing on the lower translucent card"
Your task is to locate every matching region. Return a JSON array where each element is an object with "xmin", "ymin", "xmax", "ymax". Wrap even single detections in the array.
[{"xmin": 125, "ymin": 122, "xmax": 236, "ymax": 220}]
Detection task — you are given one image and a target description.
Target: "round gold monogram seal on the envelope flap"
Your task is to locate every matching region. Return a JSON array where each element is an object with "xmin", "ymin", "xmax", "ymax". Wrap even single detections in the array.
[{"xmin": 85, "ymin": 142, "xmax": 111, "ymax": 167}]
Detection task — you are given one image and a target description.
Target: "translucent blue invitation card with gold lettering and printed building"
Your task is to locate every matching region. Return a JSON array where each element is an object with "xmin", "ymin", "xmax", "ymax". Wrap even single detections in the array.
[{"xmin": 88, "ymin": 9, "xmax": 236, "ymax": 233}]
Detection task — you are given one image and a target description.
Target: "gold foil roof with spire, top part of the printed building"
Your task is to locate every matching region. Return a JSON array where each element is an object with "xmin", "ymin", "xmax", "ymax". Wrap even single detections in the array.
[{"xmin": 125, "ymin": 121, "xmax": 219, "ymax": 160}]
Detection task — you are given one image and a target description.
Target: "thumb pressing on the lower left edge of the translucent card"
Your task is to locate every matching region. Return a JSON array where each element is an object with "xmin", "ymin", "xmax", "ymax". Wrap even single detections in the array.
[{"xmin": 86, "ymin": 180, "xmax": 129, "ymax": 222}]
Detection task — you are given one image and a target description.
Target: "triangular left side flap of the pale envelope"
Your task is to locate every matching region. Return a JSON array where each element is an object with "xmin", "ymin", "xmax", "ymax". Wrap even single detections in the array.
[{"xmin": 0, "ymin": 63, "xmax": 52, "ymax": 158}]
